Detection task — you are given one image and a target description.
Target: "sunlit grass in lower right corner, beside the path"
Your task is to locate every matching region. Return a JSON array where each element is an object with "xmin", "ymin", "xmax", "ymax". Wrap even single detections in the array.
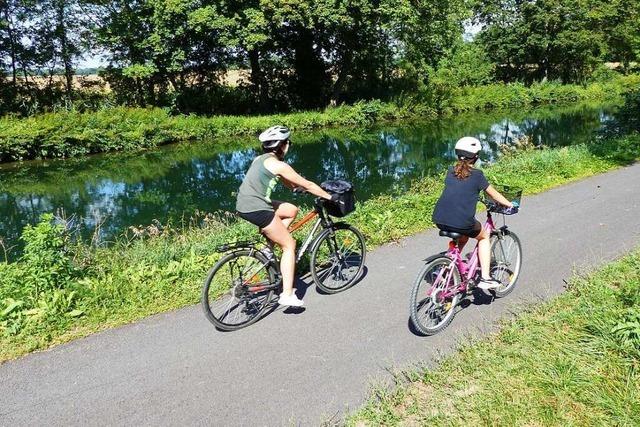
[{"xmin": 346, "ymin": 250, "xmax": 640, "ymax": 426}]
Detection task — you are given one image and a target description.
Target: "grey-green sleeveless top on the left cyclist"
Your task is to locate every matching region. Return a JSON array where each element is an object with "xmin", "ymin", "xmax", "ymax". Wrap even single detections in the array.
[{"xmin": 236, "ymin": 153, "xmax": 280, "ymax": 213}]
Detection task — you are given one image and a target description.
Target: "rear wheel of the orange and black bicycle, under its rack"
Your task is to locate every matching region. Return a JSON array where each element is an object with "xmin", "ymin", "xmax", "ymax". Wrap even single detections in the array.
[{"xmin": 202, "ymin": 249, "xmax": 276, "ymax": 331}]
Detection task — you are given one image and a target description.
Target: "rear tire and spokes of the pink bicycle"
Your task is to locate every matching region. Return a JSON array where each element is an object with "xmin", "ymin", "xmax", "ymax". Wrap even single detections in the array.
[{"xmin": 409, "ymin": 255, "xmax": 461, "ymax": 335}]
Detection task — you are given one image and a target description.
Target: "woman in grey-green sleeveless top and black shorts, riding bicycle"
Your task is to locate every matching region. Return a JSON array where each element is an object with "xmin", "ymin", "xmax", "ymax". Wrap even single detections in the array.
[{"xmin": 236, "ymin": 126, "xmax": 331, "ymax": 307}]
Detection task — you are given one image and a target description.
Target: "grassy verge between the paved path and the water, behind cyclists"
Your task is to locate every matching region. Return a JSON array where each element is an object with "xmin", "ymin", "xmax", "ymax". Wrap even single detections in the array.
[{"xmin": 0, "ymin": 134, "xmax": 640, "ymax": 361}]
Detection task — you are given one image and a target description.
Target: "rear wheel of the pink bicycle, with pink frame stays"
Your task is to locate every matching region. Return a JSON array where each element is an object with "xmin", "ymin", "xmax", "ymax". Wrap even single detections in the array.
[{"xmin": 410, "ymin": 256, "xmax": 461, "ymax": 335}]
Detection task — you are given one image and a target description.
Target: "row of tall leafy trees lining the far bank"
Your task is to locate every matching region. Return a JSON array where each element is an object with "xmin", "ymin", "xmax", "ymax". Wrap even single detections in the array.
[{"xmin": 0, "ymin": 0, "xmax": 640, "ymax": 114}]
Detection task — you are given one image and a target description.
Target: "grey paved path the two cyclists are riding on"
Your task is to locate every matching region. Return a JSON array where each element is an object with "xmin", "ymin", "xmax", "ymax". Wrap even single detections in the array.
[{"xmin": 0, "ymin": 165, "xmax": 640, "ymax": 426}]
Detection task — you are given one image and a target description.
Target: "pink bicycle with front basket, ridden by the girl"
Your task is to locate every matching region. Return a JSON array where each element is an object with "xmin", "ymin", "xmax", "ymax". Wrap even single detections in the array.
[{"xmin": 410, "ymin": 190, "xmax": 522, "ymax": 335}]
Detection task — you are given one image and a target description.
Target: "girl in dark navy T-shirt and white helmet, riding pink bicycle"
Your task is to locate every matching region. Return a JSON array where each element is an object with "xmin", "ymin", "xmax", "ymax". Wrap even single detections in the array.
[{"xmin": 432, "ymin": 136, "xmax": 513, "ymax": 289}]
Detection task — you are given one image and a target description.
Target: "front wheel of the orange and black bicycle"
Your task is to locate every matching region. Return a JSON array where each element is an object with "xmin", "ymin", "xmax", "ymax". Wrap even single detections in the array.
[{"xmin": 310, "ymin": 224, "xmax": 367, "ymax": 294}]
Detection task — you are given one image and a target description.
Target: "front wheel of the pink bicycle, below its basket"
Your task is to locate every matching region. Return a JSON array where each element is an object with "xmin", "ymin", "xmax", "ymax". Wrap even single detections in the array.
[{"xmin": 491, "ymin": 230, "xmax": 522, "ymax": 297}]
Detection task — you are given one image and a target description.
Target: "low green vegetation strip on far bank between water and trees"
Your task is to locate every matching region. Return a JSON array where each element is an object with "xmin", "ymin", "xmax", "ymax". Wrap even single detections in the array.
[{"xmin": 0, "ymin": 75, "xmax": 640, "ymax": 163}]
